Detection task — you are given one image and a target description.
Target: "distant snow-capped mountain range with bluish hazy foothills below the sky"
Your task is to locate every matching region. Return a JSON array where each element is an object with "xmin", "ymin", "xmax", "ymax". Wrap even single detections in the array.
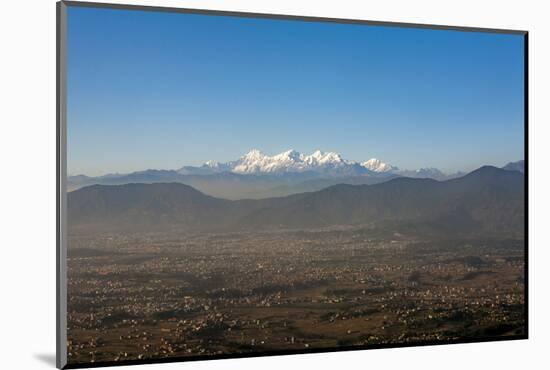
[{"xmin": 67, "ymin": 150, "xmax": 512, "ymax": 200}]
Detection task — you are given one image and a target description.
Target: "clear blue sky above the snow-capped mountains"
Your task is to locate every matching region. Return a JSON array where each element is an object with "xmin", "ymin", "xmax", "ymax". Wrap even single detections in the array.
[{"xmin": 68, "ymin": 7, "xmax": 524, "ymax": 175}]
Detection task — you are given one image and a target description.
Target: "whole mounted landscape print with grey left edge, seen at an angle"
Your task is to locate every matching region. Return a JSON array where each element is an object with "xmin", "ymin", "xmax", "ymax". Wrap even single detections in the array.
[{"xmin": 57, "ymin": 2, "xmax": 527, "ymax": 368}]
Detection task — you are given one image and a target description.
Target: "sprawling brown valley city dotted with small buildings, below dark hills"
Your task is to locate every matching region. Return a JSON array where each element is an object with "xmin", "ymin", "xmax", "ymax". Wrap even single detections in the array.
[{"xmin": 67, "ymin": 227, "xmax": 525, "ymax": 364}]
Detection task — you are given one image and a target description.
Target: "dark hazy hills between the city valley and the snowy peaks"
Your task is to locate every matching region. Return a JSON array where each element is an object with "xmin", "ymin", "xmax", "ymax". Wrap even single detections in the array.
[{"xmin": 68, "ymin": 166, "xmax": 524, "ymax": 235}]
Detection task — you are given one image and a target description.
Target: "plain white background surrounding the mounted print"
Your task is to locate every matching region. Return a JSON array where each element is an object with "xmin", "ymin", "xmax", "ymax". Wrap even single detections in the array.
[{"xmin": 0, "ymin": 0, "xmax": 550, "ymax": 370}]
